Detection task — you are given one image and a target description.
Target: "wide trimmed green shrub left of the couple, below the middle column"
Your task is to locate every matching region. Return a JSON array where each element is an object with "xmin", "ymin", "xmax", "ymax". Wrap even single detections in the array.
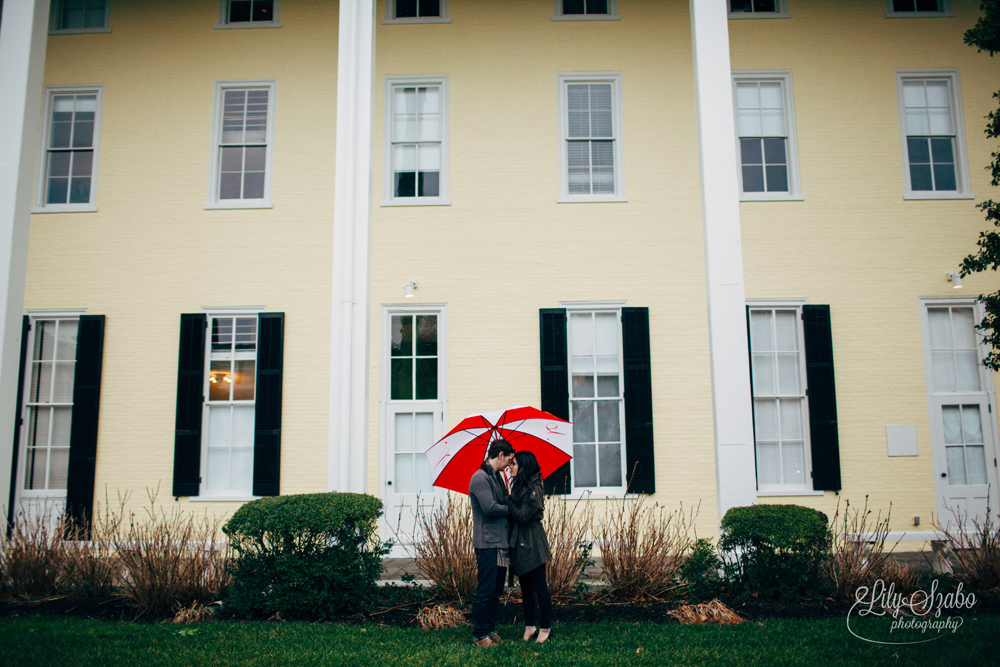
[{"xmin": 224, "ymin": 493, "xmax": 389, "ymax": 618}]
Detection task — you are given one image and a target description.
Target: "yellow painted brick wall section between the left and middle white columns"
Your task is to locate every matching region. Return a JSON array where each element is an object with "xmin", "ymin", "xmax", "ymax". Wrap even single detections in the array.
[{"xmin": 25, "ymin": 0, "xmax": 338, "ymax": 512}]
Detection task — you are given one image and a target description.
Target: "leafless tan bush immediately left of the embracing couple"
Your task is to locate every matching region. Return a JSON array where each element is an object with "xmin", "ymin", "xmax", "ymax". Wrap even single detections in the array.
[{"xmin": 412, "ymin": 497, "xmax": 477, "ymax": 601}]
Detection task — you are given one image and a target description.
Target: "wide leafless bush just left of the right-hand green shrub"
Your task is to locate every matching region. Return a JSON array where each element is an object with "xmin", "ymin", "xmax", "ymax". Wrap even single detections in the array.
[{"xmin": 598, "ymin": 498, "xmax": 697, "ymax": 600}]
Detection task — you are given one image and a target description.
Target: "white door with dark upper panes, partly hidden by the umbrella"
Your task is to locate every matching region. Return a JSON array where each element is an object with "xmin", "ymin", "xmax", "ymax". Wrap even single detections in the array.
[{"xmin": 380, "ymin": 307, "xmax": 447, "ymax": 556}]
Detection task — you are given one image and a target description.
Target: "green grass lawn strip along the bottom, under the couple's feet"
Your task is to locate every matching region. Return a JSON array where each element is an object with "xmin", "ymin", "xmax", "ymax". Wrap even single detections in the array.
[{"xmin": 0, "ymin": 616, "xmax": 1000, "ymax": 667}]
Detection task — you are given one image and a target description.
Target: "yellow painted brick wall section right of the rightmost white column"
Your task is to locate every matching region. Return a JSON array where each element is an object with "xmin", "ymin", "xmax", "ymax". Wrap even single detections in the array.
[{"xmin": 729, "ymin": 0, "xmax": 1000, "ymax": 530}]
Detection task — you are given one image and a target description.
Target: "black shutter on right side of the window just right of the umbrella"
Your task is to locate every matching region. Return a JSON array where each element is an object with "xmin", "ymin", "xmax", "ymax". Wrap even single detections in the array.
[{"xmin": 622, "ymin": 308, "xmax": 656, "ymax": 493}]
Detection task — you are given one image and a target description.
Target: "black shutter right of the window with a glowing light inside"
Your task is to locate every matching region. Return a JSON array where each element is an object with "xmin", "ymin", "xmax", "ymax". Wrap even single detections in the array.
[{"xmin": 253, "ymin": 313, "xmax": 285, "ymax": 496}]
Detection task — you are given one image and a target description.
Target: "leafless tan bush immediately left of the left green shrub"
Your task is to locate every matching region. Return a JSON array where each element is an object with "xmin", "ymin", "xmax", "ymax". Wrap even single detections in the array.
[{"xmin": 114, "ymin": 492, "xmax": 229, "ymax": 616}]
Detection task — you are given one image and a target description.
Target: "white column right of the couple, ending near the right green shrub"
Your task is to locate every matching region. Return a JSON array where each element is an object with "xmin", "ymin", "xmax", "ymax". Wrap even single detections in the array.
[{"xmin": 690, "ymin": 0, "xmax": 757, "ymax": 518}]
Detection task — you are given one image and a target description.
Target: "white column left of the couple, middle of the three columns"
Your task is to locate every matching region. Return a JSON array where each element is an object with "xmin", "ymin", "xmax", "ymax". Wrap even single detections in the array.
[{"xmin": 327, "ymin": 0, "xmax": 375, "ymax": 493}]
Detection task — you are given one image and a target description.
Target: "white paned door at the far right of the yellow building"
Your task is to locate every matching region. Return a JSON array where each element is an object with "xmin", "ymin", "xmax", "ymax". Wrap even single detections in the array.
[{"xmin": 924, "ymin": 301, "xmax": 998, "ymax": 529}]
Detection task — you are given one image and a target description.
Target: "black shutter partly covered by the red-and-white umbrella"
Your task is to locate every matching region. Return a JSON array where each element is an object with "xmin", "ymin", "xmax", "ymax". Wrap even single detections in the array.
[{"xmin": 538, "ymin": 308, "xmax": 573, "ymax": 493}]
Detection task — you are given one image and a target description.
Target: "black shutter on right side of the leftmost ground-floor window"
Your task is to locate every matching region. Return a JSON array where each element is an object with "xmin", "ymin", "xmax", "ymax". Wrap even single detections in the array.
[{"xmin": 66, "ymin": 315, "xmax": 104, "ymax": 536}]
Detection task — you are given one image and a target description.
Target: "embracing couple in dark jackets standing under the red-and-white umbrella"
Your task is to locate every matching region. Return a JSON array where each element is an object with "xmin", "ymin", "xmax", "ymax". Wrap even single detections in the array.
[{"xmin": 469, "ymin": 440, "xmax": 552, "ymax": 647}]
